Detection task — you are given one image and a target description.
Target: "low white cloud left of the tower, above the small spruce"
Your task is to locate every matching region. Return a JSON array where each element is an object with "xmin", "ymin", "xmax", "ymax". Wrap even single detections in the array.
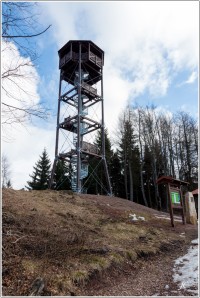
[{"xmin": 2, "ymin": 124, "xmax": 55, "ymax": 189}]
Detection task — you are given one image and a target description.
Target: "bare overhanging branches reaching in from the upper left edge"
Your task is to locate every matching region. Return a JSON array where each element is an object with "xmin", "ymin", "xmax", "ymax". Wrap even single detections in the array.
[{"xmin": 2, "ymin": 2, "xmax": 50, "ymax": 134}]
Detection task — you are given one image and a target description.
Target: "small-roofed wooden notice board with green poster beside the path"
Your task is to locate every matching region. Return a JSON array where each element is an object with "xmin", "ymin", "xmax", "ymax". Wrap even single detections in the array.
[{"xmin": 157, "ymin": 176, "xmax": 189, "ymax": 227}]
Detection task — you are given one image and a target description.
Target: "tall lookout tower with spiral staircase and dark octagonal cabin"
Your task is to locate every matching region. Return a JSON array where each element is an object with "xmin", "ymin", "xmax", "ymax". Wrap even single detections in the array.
[{"xmin": 50, "ymin": 40, "xmax": 112, "ymax": 194}]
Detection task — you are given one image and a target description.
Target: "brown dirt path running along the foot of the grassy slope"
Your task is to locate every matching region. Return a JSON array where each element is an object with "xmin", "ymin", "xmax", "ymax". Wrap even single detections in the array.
[{"xmin": 79, "ymin": 230, "xmax": 197, "ymax": 296}]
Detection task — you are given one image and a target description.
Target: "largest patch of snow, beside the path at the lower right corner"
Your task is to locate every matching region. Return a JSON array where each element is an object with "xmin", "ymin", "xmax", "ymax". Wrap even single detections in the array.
[{"xmin": 173, "ymin": 239, "xmax": 198, "ymax": 294}]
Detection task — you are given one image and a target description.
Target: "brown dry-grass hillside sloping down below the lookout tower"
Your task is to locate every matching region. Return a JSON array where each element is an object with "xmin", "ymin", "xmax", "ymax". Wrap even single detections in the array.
[{"xmin": 3, "ymin": 189, "xmax": 188, "ymax": 296}]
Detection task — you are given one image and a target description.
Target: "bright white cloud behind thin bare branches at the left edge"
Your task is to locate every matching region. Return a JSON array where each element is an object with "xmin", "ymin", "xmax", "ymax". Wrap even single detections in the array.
[{"xmin": 2, "ymin": 41, "xmax": 40, "ymax": 107}]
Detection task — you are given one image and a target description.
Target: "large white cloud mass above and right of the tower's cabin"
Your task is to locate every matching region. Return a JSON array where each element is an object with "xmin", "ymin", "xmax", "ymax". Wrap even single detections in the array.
[{"xmin": 42, "ymin": 1, "xmax": 198, "ymax": 127}]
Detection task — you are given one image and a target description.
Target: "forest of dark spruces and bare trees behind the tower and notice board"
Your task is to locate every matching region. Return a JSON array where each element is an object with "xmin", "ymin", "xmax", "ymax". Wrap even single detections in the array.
[{"xmin": 28, "ymin": 106, "xmax": 198, "ymax": 210}]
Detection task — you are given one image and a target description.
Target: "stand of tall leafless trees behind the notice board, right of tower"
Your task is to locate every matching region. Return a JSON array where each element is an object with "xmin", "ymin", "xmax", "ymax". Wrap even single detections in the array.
[{"xmin": 116, "ymin": 105, "xmax": 198, "ymax": 210}]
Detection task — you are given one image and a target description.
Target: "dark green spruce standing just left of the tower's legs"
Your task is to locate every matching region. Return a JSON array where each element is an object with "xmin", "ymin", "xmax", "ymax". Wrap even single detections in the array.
[{"xmin": 26, "ymin": 148, "xmax": 51, "ymax": 190}]
